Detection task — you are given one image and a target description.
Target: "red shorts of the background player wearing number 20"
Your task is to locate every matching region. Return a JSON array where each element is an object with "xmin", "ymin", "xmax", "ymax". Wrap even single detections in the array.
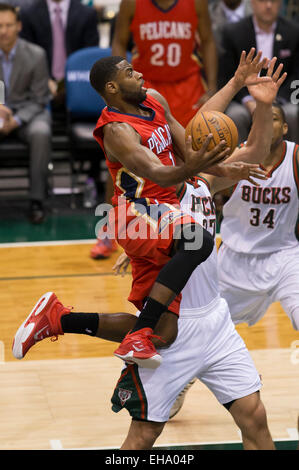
[{"xmin": 144, "ymin": 72, "xmax": 206, "ymax": 127}]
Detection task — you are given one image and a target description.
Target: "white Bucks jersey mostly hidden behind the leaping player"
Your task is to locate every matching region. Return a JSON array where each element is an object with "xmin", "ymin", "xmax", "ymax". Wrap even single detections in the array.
[{"xmin": 179, "ymin": 177, "xmax": 219, "ymax": 309}]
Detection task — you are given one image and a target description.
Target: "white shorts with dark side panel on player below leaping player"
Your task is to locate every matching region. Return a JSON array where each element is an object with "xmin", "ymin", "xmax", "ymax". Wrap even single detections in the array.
[{"xmin": 111, "ymin": 297, "xmax": 261, "ymax": 422}]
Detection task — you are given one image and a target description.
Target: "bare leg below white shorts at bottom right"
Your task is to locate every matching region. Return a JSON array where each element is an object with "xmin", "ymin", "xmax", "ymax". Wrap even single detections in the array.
[{"xmin": 229, "ymin": 392, "xmax": 275, "ymax": 450}]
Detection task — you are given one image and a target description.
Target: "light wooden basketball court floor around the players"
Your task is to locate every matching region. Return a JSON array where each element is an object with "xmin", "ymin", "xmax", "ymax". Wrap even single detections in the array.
[{"xmin": 0, "ymin": 242, "xmax": 299, "ymax": 450}]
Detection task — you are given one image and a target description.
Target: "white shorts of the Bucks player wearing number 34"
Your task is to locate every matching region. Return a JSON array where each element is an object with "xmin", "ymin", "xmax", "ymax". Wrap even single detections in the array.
[{"xmin": 218, "ymin": 244, "xmax": 299, "ymax": 328}]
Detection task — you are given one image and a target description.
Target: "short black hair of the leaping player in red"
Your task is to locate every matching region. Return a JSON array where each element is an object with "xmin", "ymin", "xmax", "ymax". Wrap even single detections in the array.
[{"xmin": 89, "ymin": 56, "xmax": 126, "ymax": 96}]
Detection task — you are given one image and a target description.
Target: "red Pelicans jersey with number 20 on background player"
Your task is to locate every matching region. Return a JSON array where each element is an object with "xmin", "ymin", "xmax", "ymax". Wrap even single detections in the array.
[{"xmin": 130, "ymin": 0, "xmax": 199, "ymax": 82}]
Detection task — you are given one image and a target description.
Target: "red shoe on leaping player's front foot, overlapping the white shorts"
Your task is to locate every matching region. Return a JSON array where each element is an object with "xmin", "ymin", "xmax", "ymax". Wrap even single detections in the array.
[{"xmin": 114, "ymin": 328, "xmax": 162, "ymax": 369}]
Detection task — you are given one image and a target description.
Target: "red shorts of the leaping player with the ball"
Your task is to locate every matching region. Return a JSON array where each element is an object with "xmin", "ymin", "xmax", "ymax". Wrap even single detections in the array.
[{"xmin": 109, "ymin": 200, "xmax": 194, "ymax": 315}]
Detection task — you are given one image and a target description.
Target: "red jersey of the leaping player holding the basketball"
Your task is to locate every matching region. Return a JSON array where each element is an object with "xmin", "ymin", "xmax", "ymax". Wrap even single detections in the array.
[{"xmin": 93, "ymin": 95, "xmax": 179, "ymax": 205}]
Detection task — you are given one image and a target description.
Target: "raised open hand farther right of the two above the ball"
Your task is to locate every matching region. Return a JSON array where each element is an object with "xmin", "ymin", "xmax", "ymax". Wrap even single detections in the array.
[{"xmin": 248, "ymin": 57, "xmax": 287, "ymax": 104}]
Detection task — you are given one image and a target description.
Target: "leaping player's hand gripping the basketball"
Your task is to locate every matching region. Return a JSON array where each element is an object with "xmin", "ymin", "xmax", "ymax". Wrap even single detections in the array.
[{"xmin": 185, "ymin": 134, "xmax": 230, "ymax": 176}]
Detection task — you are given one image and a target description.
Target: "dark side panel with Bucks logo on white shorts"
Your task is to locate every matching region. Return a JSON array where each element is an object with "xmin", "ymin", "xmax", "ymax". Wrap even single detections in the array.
[{"xmin": 111, "ymin": 364, "xmax": 147, "ymax": 419}]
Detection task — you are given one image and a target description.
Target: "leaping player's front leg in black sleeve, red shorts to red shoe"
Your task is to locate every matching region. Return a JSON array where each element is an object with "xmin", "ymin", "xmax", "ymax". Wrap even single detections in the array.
[{"xmin": 114, "ymin": 204, "xmax": 214, "ymax": 368}]
